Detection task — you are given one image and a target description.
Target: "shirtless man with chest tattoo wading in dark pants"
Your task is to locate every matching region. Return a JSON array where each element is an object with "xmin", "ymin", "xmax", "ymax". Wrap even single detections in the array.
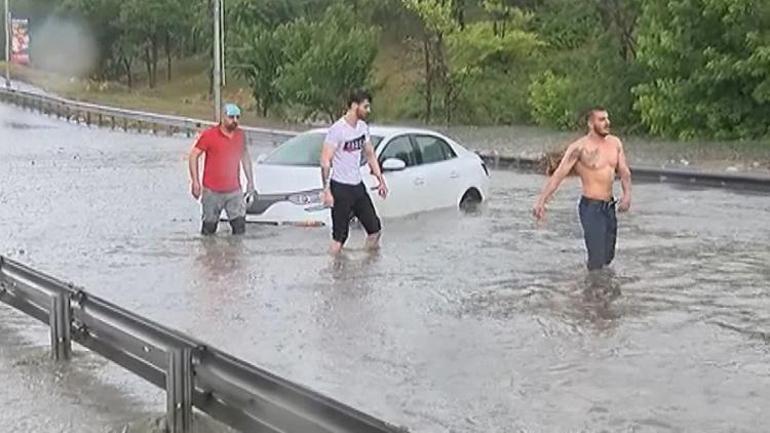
[{"xmin": 532, "ymin": 107, "xmax": 631, "ymax": 270}]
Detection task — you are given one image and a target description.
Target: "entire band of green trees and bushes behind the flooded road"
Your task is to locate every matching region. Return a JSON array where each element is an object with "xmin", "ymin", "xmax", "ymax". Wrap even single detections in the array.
[{"xmin": 12, "ymin": 0, "xmax": 770, "ymax": 139}]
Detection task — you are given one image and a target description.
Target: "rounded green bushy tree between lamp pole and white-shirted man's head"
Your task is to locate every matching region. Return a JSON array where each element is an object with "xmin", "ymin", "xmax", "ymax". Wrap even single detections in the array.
[{"xmin": 232, "ymin": 5, "xmax": 378, "ymax": 120}]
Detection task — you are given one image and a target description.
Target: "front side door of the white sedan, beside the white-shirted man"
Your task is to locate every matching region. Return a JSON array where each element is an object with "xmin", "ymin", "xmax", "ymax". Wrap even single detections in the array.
[{"xmin": 364, "ymin": 134, "xmax": 425, "ymax": 218}]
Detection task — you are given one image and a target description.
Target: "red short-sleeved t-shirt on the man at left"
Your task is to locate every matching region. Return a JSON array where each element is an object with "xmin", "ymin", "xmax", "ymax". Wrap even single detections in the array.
[{"xmin": 195, "ymin": 125, "xmax": 244, "ymax": 192}]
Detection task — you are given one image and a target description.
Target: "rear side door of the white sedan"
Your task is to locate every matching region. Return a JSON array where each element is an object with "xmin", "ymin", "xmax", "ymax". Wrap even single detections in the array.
[{"xmin": 413, "ymin": 134, "xmax": 461, "ymax": 209}]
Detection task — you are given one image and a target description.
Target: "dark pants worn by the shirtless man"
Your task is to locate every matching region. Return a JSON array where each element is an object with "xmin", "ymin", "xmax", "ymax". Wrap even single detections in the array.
[{"xmin": 578, "ymin": 197, "xmax": 618, "ymax": 270}]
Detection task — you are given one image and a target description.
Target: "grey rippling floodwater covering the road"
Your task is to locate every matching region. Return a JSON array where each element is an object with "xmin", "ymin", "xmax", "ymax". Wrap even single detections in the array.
[{"xmin": 0, "ymin": 102, "xmax": 770, "ymax": 433}]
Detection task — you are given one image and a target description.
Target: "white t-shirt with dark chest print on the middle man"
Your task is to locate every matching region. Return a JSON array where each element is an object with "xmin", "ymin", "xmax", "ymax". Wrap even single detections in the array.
[{"xmin": 325, "ymin": 117, "xmax": 371, "ymax": 185}]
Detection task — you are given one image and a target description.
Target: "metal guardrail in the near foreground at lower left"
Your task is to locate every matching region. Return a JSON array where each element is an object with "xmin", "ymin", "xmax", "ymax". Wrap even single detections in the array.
[{"xmin": 0, "ymin": 256, "xmax": 406, "ymax": 433}]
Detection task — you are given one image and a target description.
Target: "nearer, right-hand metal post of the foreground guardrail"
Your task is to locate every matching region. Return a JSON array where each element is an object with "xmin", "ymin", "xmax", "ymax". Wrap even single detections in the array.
[{"xmin": 166, "ymin": 347, "xmax": 193, "ymax": 433}]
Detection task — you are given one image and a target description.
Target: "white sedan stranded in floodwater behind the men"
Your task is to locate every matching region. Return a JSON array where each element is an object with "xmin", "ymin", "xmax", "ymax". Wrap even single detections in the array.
[{"xmin": 246, "ymin": 126, "xmax": 489, "ymax": 225}]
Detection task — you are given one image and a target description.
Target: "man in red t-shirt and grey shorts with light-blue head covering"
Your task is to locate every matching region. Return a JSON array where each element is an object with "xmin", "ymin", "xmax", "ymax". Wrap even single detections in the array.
[{"xmin": 189, "ymin": 104, "xmax": 254, "ymax": 235}]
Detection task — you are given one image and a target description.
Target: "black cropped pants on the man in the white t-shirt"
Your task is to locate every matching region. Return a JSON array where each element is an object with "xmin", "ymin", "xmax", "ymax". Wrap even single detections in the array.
[{"xmin": 330, "ymin": 181, "xmax": 382, "ymax": 244}]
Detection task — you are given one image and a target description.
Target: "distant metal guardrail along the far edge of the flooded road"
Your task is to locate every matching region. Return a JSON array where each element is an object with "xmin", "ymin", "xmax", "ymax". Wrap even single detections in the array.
[{"xmin": 0, "ymin": 88, "xmax": 770, "ymax": 191}]
